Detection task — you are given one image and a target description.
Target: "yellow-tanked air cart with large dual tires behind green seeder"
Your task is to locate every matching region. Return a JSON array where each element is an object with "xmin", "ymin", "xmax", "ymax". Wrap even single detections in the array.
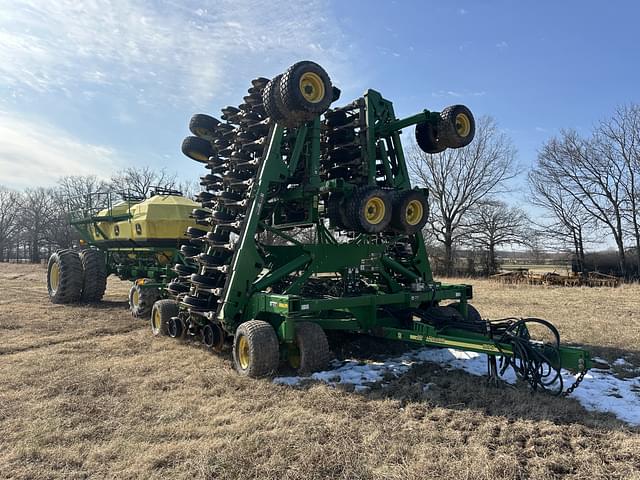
[{"xmin": 47, "ymin": 187, "xmax": 199, "ymax": 317}]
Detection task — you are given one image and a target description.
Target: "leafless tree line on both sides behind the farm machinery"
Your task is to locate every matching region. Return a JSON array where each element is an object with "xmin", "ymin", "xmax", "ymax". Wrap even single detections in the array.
[{"xmin": 0, "ymin": 104, "xmax": 640, "ymax": 276}]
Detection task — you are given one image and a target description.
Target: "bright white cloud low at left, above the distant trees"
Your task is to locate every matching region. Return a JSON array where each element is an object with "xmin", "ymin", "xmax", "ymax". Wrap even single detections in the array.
[{"xmin": 0, "ymin": 110, "xmax": 118, "ymax": 188}]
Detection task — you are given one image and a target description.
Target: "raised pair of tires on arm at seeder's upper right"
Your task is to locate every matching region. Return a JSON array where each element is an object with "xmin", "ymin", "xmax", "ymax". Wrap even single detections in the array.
[{"xmin": 415, "ymin": 105, "xmax": 476, "ymax": 154}]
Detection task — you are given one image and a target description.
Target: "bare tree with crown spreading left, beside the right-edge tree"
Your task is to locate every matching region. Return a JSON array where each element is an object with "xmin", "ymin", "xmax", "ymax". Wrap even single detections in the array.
[{"xmin": 535, "ymin": 130, "xmax": 626, "ymax": 275}]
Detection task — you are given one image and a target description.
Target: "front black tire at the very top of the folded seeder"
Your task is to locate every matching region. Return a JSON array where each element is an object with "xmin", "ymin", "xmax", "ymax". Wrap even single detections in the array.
[{"xmin": 280, "ymin": 60, "xmax": 333, "ymax": 116}]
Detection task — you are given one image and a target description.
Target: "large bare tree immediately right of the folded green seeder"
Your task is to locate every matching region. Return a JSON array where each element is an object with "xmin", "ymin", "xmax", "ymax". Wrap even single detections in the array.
[{"xmin": 409, "ymin": 117, "xmax": 517, "ymax": 275}]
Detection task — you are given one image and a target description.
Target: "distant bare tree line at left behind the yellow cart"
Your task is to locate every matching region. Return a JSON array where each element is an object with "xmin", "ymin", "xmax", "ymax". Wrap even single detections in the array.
[{"xmin": 0, "ymin": 167, "xmax": 196, "ymax": 262}]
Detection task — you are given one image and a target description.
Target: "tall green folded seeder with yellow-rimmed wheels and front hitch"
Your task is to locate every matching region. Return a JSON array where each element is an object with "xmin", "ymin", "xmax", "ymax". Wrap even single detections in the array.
[{"xmin": 139, "ymin": 61, "xmax": 591, "ymax": 394}]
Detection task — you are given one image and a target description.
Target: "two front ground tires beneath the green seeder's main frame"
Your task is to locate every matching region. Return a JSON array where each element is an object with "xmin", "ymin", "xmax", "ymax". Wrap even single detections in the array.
[{"xmin": 233, "ymin": 320, "xmax": 330, "ymax": 378}]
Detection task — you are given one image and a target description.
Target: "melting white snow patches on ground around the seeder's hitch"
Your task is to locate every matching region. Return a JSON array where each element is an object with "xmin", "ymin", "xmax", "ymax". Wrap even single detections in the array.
[{"xmin": 273, "ymin": 347, "xmax": 640, "ymax": 425}]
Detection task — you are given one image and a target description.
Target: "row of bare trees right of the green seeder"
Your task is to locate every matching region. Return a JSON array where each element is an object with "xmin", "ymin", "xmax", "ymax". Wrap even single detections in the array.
[{"xmin": 409, "ymin": 104, "xmax": 640, "ymax": 277}]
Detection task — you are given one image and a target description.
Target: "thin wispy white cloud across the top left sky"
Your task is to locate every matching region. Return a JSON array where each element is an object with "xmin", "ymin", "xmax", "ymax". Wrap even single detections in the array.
[{"xmin": 0, "ymin": 0, "xmax": 356, "ymax": 105}]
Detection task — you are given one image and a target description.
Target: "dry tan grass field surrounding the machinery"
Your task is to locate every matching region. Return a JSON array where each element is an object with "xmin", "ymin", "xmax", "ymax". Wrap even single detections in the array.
[{"xmin": 0, "ymin": 264, "xmax": 640, "ymax": 480}]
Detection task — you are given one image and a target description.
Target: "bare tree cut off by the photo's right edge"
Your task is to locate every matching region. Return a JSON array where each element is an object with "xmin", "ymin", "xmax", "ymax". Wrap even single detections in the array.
[{"xmin": 596, "ymin": 104, "xmax": 640, "ymax": 276}]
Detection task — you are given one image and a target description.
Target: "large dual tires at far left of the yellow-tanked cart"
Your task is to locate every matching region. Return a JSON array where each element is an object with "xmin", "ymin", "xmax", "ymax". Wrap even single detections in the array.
[{"xmin": 47, "ymin": 249, "xmax": 107, "ymax": 303}]
